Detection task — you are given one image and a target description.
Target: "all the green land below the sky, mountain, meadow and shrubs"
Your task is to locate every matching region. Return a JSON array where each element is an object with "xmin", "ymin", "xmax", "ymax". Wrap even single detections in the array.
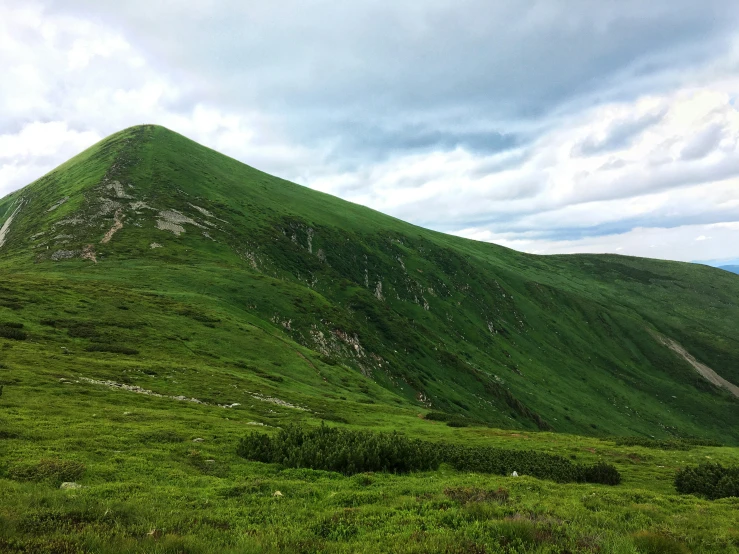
[{"xmin": 0, "ymin": 125, "xmax": 739, "ymax": 554}]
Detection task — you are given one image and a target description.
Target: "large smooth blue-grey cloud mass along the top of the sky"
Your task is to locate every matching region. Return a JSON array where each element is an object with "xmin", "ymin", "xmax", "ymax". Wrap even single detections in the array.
[{"xmin": 43, "ymin": 0, "xmax": 739, "ymax": 164}]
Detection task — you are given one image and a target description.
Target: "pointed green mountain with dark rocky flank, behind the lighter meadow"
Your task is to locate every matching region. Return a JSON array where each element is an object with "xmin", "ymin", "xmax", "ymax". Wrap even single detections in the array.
[{"xmin": 0, "ymin": 126, "xmax": 739, "ymax": 441}]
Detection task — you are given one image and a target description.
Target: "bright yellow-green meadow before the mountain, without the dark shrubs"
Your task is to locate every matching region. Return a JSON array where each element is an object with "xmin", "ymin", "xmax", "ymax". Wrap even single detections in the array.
[{"xmin": 0, "ymin": 270, "xmax": 739, "ymax": 553}]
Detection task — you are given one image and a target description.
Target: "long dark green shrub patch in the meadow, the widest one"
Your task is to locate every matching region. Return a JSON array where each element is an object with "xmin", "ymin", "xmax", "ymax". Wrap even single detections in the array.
[{"xmin": 237, "ymin": 425, "xmax": 621, "ymax": 485}]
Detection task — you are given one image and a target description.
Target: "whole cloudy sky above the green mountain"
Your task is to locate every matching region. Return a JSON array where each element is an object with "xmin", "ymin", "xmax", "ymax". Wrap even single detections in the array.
[{"xmin": 0, "ymin": 0, "xmax": 739, "ymax": 265}]
